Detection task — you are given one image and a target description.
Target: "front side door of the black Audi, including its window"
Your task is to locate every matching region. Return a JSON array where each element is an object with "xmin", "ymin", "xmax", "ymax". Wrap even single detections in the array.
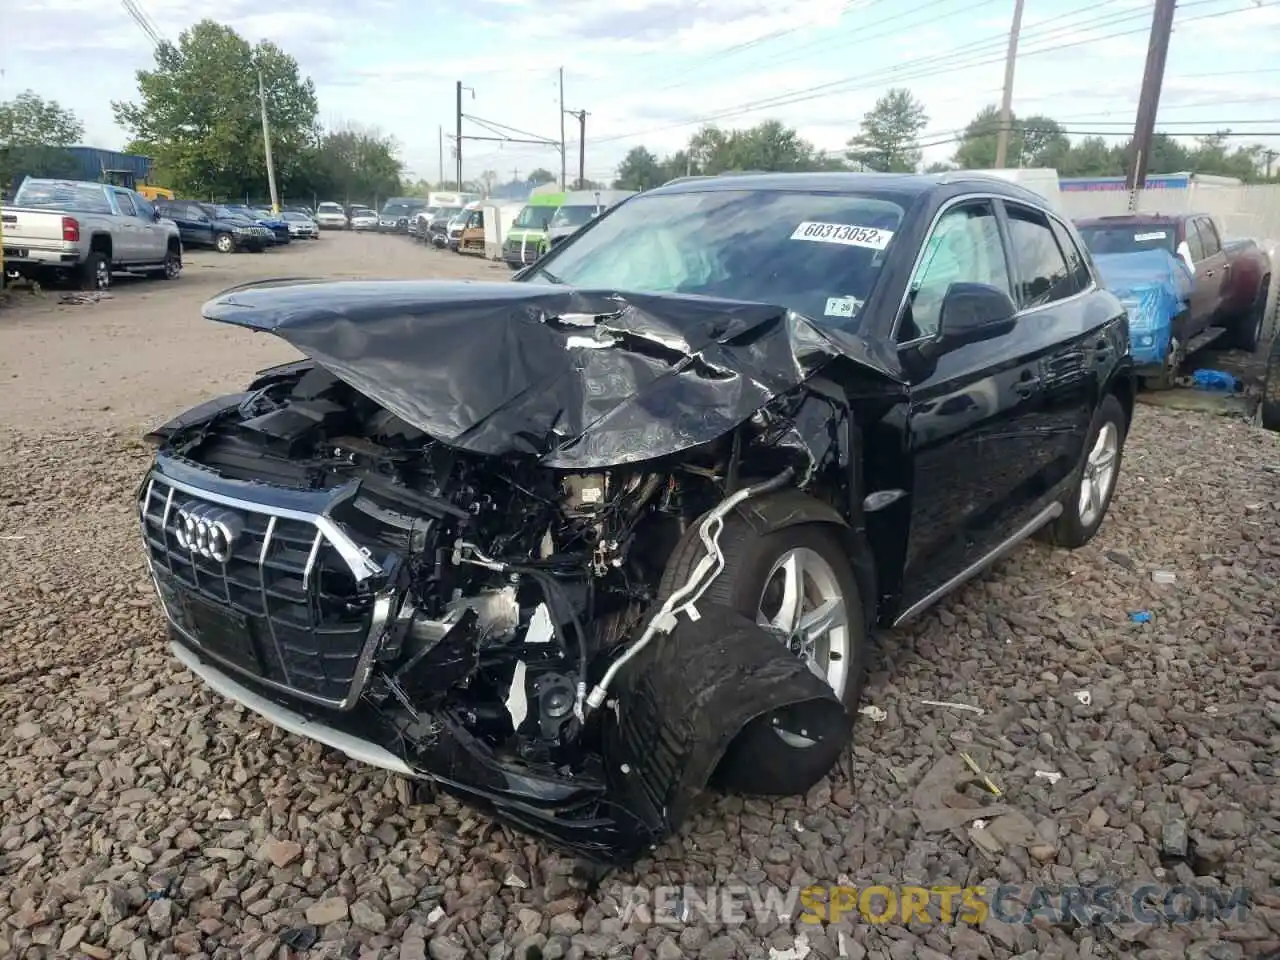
[{"xmin": 899, "ymin": 197, "xmax": 1042, "ymax": 609}]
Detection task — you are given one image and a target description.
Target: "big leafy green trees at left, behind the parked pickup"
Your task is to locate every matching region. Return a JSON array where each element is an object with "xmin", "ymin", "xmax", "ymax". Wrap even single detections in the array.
[{"xmin": 0, "ymin": 19, "xmax": 404, "ymax": 204}]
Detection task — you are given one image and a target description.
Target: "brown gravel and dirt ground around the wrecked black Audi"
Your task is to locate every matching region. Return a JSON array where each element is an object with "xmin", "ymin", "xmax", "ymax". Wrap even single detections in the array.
[{"xmin": 0, "ymin": 236, "xmax": 1280, "ymax": 960}]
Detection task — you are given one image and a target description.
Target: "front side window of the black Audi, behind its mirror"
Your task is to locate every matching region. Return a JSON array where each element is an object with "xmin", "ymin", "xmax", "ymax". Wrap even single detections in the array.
[{"xmin": 897, "ymin": 200, "xmax": 1010, "ymax": 343}]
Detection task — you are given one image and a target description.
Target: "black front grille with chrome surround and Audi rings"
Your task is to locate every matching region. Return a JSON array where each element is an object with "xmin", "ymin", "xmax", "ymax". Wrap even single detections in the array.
[{"xmin": 140, "ymin": 475, "xmax": 380, "ymax": 709}]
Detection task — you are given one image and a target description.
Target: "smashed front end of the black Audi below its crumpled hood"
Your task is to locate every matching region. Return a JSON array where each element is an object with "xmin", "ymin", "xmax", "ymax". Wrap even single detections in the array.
[{"xmin": 140, "ymin": 280, "xmax": 880, "ymax": 861}]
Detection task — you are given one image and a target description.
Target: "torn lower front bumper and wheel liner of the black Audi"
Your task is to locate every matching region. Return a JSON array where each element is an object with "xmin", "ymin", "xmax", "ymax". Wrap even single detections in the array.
[{"xmin": 172, "ymin": 604, "xmax": 850, "ymax": 865}]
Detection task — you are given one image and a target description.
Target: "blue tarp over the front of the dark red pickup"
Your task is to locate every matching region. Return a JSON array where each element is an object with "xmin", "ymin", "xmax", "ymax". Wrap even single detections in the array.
[{"xmin": 1093, "ymin": 250, "xmax": 1196, "ymax": 365}]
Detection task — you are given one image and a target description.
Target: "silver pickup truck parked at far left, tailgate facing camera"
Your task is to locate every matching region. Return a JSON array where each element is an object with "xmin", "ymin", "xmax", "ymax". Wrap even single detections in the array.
[{"xmin": 0, "ymin": 177, "xmax": 182, "ymax": 291}]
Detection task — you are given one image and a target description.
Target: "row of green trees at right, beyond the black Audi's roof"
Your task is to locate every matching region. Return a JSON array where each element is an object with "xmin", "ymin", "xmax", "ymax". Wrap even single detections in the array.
[{"xmin": 613, "ymin": 88, "xmax": 1280, "ymax": 189}]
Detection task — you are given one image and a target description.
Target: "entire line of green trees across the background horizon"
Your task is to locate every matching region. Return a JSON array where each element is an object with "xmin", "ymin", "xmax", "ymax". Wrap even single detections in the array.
[{"xmin": 0, "ymin": 54, "xmax": 1280, "ymax": 204}]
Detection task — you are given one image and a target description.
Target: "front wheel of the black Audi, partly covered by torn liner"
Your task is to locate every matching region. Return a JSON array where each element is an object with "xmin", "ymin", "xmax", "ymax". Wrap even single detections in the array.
[{"xmin": 659, "ymin": 515, "xmax": 869, "ymax": 795}]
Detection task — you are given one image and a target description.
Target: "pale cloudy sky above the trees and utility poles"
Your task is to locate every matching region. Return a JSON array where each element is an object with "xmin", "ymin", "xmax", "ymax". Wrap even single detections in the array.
[{"xmin": 0, "ymin": 0, "xmax": 1280, "ymax": 179}]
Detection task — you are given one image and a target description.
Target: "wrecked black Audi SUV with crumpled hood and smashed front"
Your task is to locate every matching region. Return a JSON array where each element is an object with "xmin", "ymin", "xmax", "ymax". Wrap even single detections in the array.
[{"xmin": 138, "ymin": 173, "xmax": 1134, "ymax": 864}]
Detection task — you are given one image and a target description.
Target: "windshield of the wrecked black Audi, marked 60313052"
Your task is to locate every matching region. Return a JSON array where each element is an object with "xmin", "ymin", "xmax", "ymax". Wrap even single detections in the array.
[{"xmin": 517, "ymin": 191, "xmax": 902, "ymax": 326}]
